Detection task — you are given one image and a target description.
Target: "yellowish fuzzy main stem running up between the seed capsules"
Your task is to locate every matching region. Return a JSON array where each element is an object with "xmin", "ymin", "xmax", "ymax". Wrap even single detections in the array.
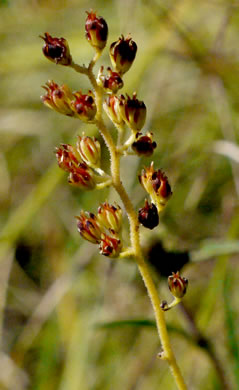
[{"xmin": 73, "ymin": 58, "xmax": 187, "ymax": 390}]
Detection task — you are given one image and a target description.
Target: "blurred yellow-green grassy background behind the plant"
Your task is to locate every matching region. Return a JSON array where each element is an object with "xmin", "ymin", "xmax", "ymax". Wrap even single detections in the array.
[{"xmin": 0, "ymin": 0, "xmax": 239, "ymax": 390}]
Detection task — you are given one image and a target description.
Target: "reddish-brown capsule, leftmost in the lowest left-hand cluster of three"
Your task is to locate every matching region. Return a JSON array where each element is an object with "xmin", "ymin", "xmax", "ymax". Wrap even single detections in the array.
[{"xmin": 76, "ymin": 211, "xmax": 102, "ymax": 244}]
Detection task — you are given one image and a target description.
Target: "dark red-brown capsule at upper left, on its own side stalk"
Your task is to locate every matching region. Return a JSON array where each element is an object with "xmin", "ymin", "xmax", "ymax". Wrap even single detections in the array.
[{"xmin": 40, "ymin": 32, "xmax": 72, "ymax": 66}]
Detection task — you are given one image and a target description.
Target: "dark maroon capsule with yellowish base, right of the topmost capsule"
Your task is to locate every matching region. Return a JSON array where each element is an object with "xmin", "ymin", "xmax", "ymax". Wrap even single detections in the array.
[{"xmin": 110, "ymin": 35, "xmax": 137, "ymax": 74}]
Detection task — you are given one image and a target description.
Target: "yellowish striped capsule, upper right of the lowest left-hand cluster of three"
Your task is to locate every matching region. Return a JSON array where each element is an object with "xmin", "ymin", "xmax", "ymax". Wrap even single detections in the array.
[{"xmin": 97, "ymin": 202, "xmax": 122, "ymax": 233}]
